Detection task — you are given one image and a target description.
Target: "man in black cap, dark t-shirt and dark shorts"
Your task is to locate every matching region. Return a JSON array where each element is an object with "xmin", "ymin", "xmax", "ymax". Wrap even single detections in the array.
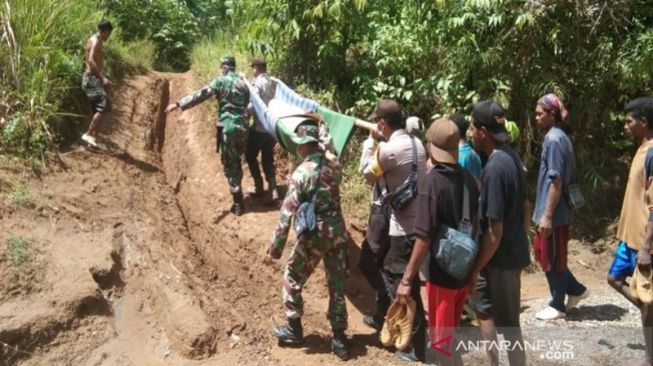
[{"xmin": 470, "ymin": 100, "xmax": 530, "ymax": 366}]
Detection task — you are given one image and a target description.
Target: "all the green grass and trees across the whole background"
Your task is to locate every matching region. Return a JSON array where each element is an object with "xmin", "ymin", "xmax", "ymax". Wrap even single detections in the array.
[{"xmin": 0, "ymin": 0, "xmax": 653, "ymax": 230}]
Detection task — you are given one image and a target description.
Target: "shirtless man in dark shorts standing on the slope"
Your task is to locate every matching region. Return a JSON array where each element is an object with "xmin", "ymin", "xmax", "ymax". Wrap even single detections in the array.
[{"xmin": 82, "ymin": 20, "xmax": 113, "ymax": 149}]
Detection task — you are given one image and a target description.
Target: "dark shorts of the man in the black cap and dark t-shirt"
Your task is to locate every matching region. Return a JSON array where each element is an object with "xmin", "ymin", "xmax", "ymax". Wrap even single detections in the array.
[{"xmin": 469, "ymin": 267, "xmax": 521, "ymax": 328}]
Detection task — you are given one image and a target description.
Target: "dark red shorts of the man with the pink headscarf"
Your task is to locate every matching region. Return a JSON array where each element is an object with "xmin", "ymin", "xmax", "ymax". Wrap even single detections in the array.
[{"xmin": 533, "ymin": 225, "xmax": 569, "ymax": 272}]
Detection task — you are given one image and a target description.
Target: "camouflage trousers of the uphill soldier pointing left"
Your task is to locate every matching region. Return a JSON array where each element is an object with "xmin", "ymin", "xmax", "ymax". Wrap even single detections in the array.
[{"xmin": 220, "ymin": 123, "xmax": 249, "ymax": 193}]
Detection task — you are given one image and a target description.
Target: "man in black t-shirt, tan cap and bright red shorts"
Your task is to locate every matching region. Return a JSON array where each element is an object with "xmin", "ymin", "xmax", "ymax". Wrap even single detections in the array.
[{"xmin": 397, "ymin": 118, "xmax": 479, "ymax": 366}]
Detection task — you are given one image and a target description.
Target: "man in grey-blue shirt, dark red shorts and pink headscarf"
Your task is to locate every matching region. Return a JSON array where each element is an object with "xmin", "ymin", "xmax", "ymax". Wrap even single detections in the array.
[{"xmin": 533, "ymin": 94, "xmax": 589, "ymax": 320}]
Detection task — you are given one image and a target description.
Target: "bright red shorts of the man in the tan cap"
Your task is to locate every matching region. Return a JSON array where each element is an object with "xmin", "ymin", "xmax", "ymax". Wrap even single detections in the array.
[{"xmin": 426, "ymin": 282, "xmax": 469, "ymax": 353}]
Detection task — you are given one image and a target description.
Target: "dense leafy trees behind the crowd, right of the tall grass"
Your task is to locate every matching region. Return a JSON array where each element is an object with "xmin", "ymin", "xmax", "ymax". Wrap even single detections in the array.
[{"xmin": 216, "ymin": 0, "xmax": 653, "ymax": 230}]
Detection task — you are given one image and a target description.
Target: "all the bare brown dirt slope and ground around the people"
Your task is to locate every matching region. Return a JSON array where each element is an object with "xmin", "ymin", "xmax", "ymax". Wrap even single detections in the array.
[{"xmin": 0, "ymin": 73, "xmax": 643, "ymax": 365}]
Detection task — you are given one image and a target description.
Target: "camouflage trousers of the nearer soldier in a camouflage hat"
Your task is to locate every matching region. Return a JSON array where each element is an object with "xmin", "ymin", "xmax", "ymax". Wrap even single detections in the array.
[{"xmin": 283, "ymin": 236, "xmax": 347, "ymax": 330}]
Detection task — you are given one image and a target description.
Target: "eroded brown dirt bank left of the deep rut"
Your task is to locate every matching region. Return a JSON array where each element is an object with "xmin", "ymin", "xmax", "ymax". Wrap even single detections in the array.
[{"xmin": 0, "ymin": 74, "xmax": 217, "ymax": 364}]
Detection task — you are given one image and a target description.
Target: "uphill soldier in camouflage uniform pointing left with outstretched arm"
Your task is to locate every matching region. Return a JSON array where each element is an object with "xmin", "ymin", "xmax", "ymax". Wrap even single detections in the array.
[{"xmin": 166, "ymin": 56, "xmax": 249, "ymax": 216}]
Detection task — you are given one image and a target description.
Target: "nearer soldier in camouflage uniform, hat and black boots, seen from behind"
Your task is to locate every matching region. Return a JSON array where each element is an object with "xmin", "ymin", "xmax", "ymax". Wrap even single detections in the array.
[{"xmin": 264, "ymin": 125, "xmax": 349, "ymax": 360}]
